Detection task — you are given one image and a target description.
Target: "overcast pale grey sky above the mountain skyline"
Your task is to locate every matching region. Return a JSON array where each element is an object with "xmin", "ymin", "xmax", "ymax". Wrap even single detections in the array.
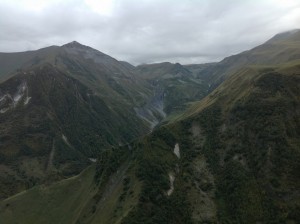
[{"xmin": 0, "ymin": 0, "xmax": 300, "ymax": 65}]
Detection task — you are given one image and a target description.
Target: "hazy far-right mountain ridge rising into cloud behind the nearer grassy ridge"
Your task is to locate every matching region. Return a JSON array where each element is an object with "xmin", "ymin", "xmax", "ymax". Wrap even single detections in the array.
[{"xmin": 195, "ymin": 30, "xmax": 300, "ymax": 90}]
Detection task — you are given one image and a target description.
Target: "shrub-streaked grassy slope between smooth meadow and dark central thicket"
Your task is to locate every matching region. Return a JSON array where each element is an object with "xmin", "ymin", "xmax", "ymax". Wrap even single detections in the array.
[{"xmin": 78, "ymin": 146, "xmax": 140, "ymax": 223}]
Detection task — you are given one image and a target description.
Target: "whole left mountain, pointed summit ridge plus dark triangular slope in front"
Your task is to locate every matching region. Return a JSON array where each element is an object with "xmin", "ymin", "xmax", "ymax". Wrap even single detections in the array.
[{"xmin": 0, "ymin": 42, "xmax": 159, "ymax": 198}]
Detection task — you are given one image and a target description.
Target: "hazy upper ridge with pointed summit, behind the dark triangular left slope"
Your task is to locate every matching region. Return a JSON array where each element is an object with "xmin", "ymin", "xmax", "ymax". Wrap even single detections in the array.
[{"xmin": 0, "ymin": 41, "xmax": 151, "ymax": 110}]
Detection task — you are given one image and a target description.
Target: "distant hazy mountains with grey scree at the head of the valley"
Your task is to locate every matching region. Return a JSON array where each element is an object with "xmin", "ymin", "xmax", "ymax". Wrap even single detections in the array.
[{"xmin": 137, "ymin": 62, "xmax": 209, "ymax": 119}]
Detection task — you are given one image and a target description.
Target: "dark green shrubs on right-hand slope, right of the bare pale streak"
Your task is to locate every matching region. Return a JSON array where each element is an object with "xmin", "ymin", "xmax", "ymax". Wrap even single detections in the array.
[{"xmin": 184, "ymin": 70, "xmax": 300, "ymax": 223}]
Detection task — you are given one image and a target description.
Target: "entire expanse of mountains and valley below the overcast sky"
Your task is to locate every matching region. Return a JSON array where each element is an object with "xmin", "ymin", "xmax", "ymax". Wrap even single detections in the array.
[{"xmin": 0, "ymin": 30, "xmax": 300, "ymax": 224}]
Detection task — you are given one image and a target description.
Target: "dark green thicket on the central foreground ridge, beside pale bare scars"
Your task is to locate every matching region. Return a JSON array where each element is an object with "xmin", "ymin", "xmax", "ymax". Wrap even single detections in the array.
[{"xmin": 122, "ymin": 127, "xmax": 192, "ymax": 224}]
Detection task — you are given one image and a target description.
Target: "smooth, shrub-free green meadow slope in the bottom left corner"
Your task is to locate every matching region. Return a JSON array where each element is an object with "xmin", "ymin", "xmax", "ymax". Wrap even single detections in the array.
[{"xmin": 0, "ymin": 165, "xmax": 95, "ymax": 224}]
